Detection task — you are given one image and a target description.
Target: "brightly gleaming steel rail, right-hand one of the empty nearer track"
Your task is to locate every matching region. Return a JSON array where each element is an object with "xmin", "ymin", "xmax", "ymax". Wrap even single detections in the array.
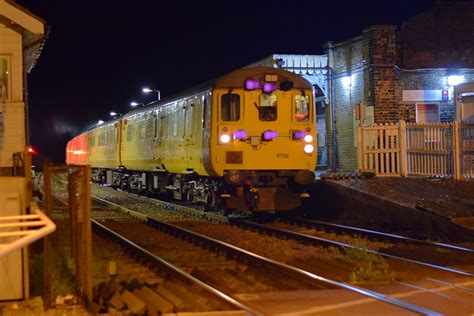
[{"xmin": 96, "ymin": 196, "xmax": 441, "ymax": 315}]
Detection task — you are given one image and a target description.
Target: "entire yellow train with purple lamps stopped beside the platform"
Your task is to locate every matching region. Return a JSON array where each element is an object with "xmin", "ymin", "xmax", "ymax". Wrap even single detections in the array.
[{"xmin": 66, "ymin": 67, "xmax": 317, "ymax": 212}]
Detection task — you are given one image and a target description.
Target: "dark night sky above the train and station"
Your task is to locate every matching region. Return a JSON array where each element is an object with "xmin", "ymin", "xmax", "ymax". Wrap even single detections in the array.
[{"xmin": 17, "ymin": 0, "xmax": 433, "ymax": 162}]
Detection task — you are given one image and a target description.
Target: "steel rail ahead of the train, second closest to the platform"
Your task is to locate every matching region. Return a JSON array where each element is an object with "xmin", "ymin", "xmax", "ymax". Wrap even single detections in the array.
[{"xmin": 231, "ymin": 220, "xmax": 474, "ymax": 277}]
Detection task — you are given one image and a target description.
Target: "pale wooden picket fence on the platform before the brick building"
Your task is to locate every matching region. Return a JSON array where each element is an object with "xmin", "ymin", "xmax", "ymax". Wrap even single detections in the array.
[{"xmin": 358, "ymin": 121, "xmax": 474, "ymax": 179}]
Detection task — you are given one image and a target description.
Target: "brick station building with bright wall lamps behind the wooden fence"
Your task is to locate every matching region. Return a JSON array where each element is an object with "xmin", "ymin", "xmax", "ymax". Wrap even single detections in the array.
[{"xmin": 326, "ymin": 1, "xmax": 474, "ymax": 170}]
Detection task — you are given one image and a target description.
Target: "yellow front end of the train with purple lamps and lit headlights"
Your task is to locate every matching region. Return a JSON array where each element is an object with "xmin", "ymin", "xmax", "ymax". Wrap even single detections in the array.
[{"xmin": 209, "ymin": 67, "xmax": 317, "ymax": 211}]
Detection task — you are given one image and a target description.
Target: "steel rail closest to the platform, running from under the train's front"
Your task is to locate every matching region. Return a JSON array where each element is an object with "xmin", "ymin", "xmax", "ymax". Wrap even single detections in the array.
[{"xmin": 278, "ymin": 215, "xmax": 474, "ymax": 252}]
